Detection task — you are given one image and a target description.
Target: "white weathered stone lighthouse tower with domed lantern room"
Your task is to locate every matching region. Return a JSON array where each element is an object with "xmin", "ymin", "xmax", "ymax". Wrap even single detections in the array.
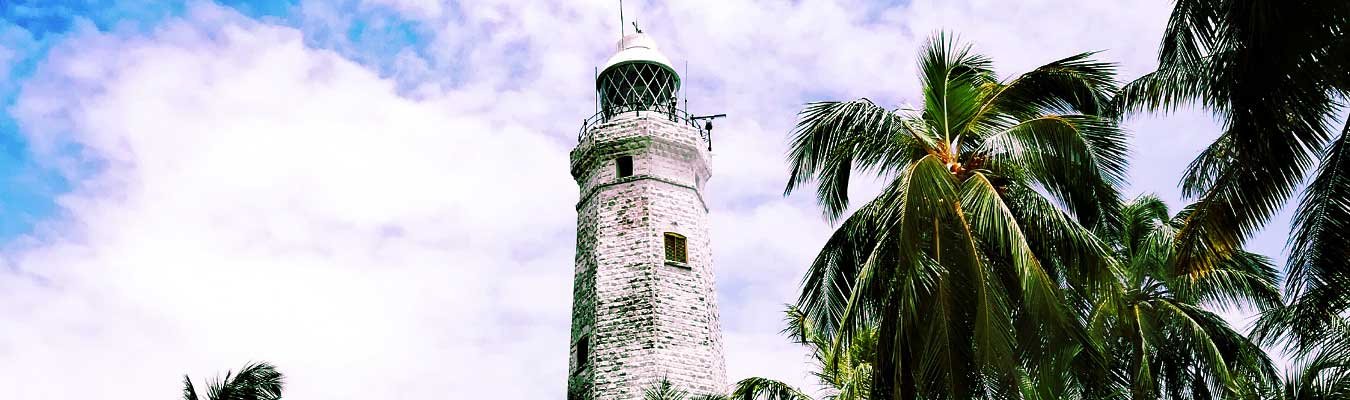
[{"xmin": 567, "ymin": 32, "xmax": 726, "ymax": 400}]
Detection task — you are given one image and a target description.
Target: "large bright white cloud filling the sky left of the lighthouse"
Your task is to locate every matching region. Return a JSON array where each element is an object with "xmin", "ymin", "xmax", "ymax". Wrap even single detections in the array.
[{"xmin": 0, "ymin": 7, "xmax": 575, "ymax": 399}]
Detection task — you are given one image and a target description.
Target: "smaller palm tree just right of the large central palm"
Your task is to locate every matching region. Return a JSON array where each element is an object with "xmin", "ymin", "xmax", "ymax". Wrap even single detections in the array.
[{"xmin": 1088, "ymin": 196, "xmax": 1281, "ymax": 399}]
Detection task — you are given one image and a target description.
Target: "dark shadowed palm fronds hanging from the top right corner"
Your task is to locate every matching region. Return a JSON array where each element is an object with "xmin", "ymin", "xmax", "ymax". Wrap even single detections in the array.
[{"xmin": 1115, "ymin": 0, "xmax": 1350, "ymax": 283}]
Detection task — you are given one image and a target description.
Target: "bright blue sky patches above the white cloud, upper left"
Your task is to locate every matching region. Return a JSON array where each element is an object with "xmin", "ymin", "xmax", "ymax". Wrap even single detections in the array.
[{"xmin": 0, "ymin": 0, "xmax": 442, "ymax": 243}]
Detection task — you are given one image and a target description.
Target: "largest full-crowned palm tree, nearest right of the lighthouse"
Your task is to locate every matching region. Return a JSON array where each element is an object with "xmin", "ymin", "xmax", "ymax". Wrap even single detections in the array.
[{"xmin": 786, "ymin": 34, "xmax": 1126, "ymax": 399}]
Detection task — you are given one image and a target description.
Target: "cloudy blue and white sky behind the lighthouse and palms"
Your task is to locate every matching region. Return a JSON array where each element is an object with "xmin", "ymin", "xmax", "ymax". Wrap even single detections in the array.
[{"xmin": 0, "ymin": 0, "xmax": 1306, "ymax": 399}]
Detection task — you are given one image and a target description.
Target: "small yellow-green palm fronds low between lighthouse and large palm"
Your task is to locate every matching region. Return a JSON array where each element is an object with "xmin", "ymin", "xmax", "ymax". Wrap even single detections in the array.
[{"xmin": 729, "ymin": 305, "xmax": 876, "ymax": 400}]
